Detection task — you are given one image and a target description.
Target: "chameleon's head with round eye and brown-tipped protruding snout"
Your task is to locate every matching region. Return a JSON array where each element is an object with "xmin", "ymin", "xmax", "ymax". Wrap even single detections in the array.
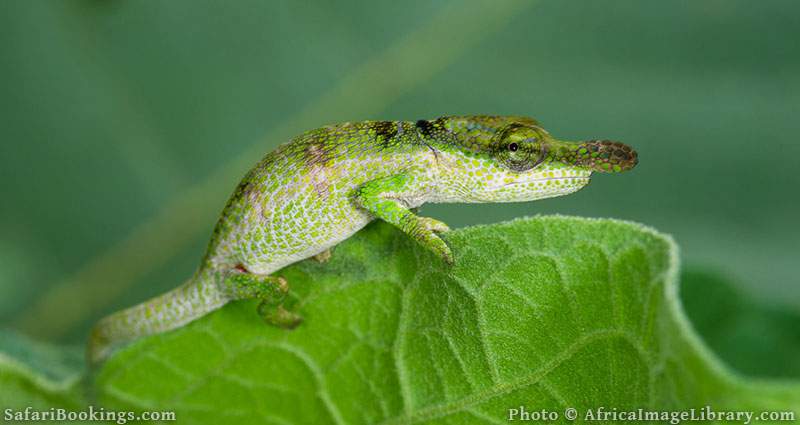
[{"xmin": 424, "ymin": 116, "xmax": 638, "ymax": 202}]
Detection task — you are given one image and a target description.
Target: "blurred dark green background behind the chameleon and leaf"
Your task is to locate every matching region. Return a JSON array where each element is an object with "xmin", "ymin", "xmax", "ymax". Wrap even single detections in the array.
[{"xmin": 0, "ymin": 0, "xmax": 800, "ymax": 375}]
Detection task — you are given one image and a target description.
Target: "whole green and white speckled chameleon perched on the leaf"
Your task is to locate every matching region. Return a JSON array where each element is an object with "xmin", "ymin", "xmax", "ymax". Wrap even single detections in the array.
[{"xmin": 88, "ymin": 116, "xmax": 637, "ymax": 362}]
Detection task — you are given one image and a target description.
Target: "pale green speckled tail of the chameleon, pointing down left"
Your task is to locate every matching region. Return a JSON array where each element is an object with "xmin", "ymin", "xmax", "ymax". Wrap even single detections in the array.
[{"xmin": 86, "ymin": 272, "xmax": 228, "ymax": 364}]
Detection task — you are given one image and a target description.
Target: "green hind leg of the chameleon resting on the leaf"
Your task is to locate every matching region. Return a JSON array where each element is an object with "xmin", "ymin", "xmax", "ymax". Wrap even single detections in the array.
[{"xmin": 224, "ymin": 270, "xmax": 303, "ymax": 329}]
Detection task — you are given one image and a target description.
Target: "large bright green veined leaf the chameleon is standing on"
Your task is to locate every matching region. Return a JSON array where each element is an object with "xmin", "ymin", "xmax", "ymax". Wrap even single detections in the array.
[{"xmin": 83, "ymin": 217, "xmax": 800, "ymax": 424}]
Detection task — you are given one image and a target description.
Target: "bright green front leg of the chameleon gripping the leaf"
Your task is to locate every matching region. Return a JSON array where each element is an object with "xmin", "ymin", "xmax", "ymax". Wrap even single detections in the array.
[{"xmin": 354, "ymin": 174, "xmax": 453, "ymax": 264}]
